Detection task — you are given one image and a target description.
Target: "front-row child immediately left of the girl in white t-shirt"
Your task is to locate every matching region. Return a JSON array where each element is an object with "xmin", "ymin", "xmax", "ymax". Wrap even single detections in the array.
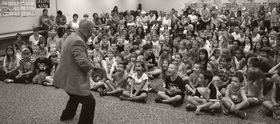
[{"xmin": 100, "ymin": 62, "xmax": 128, "ymax": 96}]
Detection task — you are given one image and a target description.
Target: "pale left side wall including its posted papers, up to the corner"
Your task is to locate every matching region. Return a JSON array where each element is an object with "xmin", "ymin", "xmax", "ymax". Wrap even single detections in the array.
[{"xmin": 0, "ymin": 0, "xmax": 57, "ymax": 38}]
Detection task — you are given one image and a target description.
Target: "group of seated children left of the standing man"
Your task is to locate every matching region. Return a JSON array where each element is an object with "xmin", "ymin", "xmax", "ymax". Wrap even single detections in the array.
[{"xmin": 0, "ymin": 31, "xmax": 59, "ymax": 85}]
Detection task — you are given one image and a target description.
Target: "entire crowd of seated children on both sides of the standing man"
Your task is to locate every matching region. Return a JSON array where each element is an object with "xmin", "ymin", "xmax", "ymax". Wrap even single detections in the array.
[{"xmin": 0, "ymin": 4, "xmax": 280, "ymax": 118}]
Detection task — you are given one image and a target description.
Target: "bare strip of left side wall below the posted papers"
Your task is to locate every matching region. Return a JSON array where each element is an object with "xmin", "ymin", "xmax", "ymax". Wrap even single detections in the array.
[{"xmin": 0, "ymin": 0, "xmax": 56, "ymax": 34}]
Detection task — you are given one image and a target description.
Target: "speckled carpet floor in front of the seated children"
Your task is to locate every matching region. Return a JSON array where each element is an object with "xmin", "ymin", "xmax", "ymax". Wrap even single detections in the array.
[{"xmin": 0, "ymin": 82, "xmax": 279, "ymax": 124}]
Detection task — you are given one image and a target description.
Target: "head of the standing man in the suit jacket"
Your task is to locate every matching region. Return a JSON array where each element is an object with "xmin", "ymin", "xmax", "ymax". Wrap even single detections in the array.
[{"xmin": 78, "ymin": 19, "xmax": 94, "ymax": 38}]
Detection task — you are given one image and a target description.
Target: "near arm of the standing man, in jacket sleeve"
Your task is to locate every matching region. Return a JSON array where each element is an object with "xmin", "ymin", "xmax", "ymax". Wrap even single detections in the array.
[{"xmin": 71, "ymin": 40, "xmax": 93, "ymax": 72}]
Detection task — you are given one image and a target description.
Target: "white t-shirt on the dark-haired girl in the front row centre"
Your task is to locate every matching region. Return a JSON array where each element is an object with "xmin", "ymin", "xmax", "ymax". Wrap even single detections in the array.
[{"xmin": 132, "ymin": 73, "xmax": 149, "ymax": 91}]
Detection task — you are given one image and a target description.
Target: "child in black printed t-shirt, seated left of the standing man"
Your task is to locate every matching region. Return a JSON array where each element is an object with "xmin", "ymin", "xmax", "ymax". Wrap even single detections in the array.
[{"xmin": 32, "ymin": 52, "xmax": 52, "ymax": 84}]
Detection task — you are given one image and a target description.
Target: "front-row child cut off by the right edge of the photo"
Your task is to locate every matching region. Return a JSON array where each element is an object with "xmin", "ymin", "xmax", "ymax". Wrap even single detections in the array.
[{"xmin": 263, "ymin": 74, "xmax": 280, "ymax": 116}]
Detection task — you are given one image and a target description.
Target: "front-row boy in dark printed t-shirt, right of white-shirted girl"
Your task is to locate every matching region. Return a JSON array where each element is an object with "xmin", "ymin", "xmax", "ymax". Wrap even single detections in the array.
[{"xmin": 155, "ymin": 63, "xmax": 186, "ymax": 107}]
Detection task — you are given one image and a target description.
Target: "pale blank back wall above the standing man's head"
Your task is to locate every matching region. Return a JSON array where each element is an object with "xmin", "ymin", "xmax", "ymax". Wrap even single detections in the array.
[{"xmin": 57, "ymin": 0, "xmax": 138, "ymax": 21}]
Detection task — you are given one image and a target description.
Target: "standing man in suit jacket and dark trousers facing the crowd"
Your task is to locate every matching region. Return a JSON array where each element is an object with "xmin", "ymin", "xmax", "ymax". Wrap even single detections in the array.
[{"xmin": 54, "ymin": 19, "xmax": 95, "ymax": 124}]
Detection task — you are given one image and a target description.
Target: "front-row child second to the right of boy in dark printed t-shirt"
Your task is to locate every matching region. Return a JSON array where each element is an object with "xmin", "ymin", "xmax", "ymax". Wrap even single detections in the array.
[{"xmin": 221, "ymin": 72, "xmax": 249, "ymax": 119}]
